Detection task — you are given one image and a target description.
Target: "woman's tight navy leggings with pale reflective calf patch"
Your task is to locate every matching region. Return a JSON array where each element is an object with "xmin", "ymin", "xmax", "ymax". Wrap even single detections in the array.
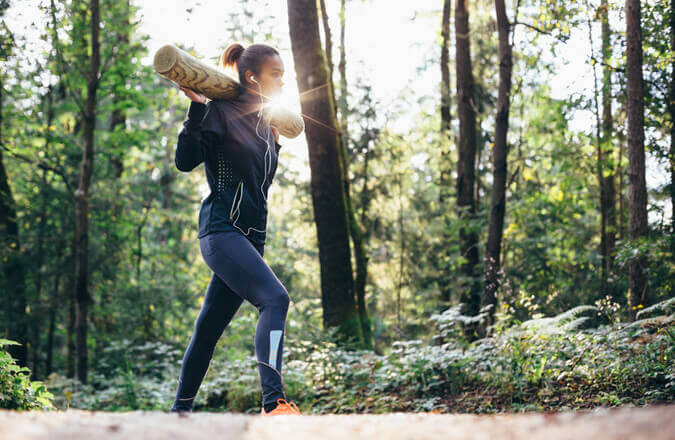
[{"xmin": 171, "ymin": 231, "xmax": 290, "ymax": 411}]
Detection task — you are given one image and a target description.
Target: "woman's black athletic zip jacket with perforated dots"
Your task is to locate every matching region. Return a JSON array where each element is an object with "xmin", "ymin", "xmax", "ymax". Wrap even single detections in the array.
[{"xmin": 175, "ymin": 86, "xmax": 281, "ymax": 244}]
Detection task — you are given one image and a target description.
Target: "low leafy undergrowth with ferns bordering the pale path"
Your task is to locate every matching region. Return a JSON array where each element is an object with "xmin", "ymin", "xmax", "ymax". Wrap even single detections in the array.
[{"xmin": 43, "ymin": 303, "xmax": 675, "ymax": 414}]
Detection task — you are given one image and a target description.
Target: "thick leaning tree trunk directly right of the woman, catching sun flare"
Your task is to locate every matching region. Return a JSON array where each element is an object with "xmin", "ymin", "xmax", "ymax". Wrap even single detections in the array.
[{"xmin": 288, "ymin": 0, "xmax": 363, "ymax": 345}]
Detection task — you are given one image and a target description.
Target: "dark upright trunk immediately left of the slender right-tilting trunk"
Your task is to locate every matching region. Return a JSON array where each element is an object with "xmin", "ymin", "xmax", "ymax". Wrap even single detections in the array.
[{"xmin": 455, "ymin": 0, "xmax": 480, "ymax": 340}]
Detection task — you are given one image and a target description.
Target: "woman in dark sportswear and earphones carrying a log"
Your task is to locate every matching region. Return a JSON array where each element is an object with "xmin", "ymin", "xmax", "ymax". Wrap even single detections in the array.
[{"xmin": 171, "ymin": 43, "xmax": 300, "ymax": 415}]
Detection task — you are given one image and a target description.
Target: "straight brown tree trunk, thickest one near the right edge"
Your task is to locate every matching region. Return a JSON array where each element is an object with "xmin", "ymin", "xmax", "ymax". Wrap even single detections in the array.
[{"xmin": 626, "ymin": 0, "xmax": 649, "ymax": 321}]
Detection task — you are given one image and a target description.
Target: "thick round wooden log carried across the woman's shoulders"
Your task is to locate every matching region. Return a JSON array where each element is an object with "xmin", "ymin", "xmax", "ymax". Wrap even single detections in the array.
[{"xmin": 153, "ymin": 44, "xmax": 305, "ymax": 139}]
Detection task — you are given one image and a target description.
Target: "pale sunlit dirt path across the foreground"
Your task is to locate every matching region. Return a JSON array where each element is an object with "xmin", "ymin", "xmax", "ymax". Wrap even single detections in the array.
[{"xmin": 0, "ymin": 405, "xmax": 675, "ymax": 440}]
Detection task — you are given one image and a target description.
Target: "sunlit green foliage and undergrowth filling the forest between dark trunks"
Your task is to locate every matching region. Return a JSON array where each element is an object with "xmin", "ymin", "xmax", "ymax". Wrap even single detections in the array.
[{"xmin": 0, "ymin": 0, "xmax": 675, "ymax": 412}]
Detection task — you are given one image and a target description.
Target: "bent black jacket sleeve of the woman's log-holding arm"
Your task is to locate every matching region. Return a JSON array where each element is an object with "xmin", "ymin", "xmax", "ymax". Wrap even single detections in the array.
[{"xmin": 174, "ymin": 101, "xmax": 227, "ymax": 172}]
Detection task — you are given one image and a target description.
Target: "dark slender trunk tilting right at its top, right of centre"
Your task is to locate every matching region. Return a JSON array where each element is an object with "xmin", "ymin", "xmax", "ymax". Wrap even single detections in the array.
[{"xmin": 481, "ymin": 0, "xmax": 513, "ymax": 333}]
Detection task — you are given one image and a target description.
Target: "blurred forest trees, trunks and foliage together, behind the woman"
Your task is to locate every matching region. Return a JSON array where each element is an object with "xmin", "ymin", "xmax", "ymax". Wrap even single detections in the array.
[{"xmin": 0, "ymin": 0, "xmax": 675, "ymax": 408}]
